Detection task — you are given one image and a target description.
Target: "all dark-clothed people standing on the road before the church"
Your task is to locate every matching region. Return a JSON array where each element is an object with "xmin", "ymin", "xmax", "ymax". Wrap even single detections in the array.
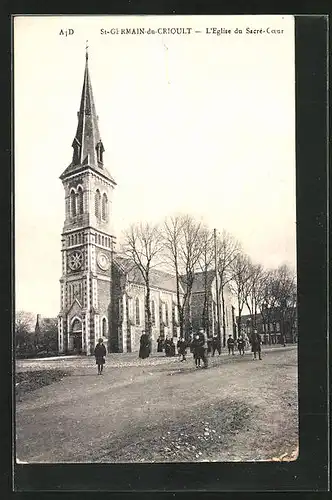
[{"xmin": 94, "ymin": 329, "xmax": 262, "ymax": 375}]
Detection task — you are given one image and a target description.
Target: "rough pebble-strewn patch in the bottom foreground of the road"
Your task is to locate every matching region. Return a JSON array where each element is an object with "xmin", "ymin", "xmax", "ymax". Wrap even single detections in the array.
[{"xmin": 98, "ymin": 399, "xmax": 254, "ymax": 463}]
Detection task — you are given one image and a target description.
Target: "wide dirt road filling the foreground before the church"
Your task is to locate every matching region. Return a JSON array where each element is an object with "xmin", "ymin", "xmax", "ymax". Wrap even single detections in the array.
[{"xmin": 16, "ymin": 347, "xmax": 297, "ymax": 463}]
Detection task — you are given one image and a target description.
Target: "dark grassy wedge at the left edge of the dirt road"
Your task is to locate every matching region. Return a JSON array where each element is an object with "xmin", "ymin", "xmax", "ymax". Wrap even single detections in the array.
[{"xmin": 15, "ymin": 369, "xmax": 70, "ymax": 401}]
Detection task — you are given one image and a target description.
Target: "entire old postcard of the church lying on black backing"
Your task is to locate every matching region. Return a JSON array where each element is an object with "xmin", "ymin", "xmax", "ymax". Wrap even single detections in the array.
[{"xmin": 14, "ymin": 15, "xmax": 299, "ymax": 464}]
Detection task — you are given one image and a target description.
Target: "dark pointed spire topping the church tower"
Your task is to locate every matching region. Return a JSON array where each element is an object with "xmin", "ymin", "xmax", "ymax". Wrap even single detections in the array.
[{"xmin": 72, "ymin": 46, "xmax": 104, "ymax": 169}]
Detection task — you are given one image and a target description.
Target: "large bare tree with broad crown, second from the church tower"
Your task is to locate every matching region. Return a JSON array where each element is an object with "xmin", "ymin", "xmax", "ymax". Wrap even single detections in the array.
[{"xmin": 163, "ymin": 215, "xmax": 202, "ymax": 338}]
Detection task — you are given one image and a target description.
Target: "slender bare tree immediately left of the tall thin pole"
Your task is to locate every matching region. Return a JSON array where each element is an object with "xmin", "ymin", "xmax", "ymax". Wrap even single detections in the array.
[{"xmin": 199, "ymin": 227, "xmax": 214, "ymax": 336}]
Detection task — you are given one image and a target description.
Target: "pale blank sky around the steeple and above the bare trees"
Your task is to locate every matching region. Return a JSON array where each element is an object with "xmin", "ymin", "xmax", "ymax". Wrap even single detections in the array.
[{"xmin": 14, "ymin": 16, "xmax": 296, "ymax": 316}]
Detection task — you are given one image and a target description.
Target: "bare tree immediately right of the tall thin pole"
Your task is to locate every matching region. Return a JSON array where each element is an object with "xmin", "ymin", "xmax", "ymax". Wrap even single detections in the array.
[{"xmin": 217, "ymin": 230, "xmax": 241, "ymax": 347}]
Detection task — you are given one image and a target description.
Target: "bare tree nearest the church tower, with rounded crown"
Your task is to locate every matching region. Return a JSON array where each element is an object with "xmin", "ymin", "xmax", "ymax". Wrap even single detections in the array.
[{"xmin": 122, "ymin": 223, "xmax": 162, "ymax": 336}]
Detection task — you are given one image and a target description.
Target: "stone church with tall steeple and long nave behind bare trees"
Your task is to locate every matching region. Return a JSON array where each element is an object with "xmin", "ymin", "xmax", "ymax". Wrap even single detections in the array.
[{"xmin": 58, "ymin": 52, "xmax": 233, "ymax": 355}]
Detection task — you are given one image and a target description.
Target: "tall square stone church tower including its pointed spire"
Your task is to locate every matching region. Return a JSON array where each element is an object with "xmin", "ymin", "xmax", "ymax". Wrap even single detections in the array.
[{"xmin": 58, "ymin": 48, "xmax": 116, "ymax": 354}]
